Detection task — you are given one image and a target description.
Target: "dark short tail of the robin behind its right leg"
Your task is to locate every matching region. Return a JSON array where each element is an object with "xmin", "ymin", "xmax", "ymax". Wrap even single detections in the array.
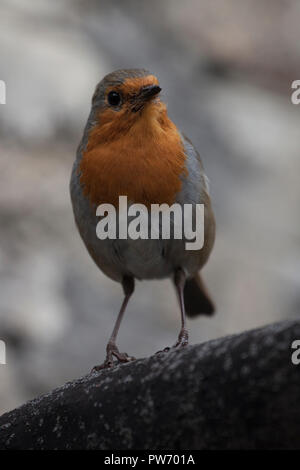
[{"xmin": 184, "ymin": 273, "xmax": 215, "ymax": 317}]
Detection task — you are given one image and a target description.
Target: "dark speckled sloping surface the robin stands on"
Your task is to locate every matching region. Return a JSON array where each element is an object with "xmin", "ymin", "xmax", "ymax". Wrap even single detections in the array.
[{"xmin": 0, "ymin": 322, "xmax": 300, "ymax": 450}]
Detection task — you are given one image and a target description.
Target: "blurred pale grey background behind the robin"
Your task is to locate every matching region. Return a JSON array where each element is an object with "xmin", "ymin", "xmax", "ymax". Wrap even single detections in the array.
[{"xmin": 0, "ymin": 0, "xmax": 300, "ymax": 413}]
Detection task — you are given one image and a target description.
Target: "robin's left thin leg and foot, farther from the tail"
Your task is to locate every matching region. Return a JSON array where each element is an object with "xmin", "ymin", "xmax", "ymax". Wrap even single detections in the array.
[{"xmin": 92, "ymin": 276, "xmax": 135, "ymax": 372}]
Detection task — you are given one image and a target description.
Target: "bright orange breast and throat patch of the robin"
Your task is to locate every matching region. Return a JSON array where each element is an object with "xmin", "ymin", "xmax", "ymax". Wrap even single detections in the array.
[{"xmin": 80, "ymin": 102, "xmax": 186, "ymax": 207}]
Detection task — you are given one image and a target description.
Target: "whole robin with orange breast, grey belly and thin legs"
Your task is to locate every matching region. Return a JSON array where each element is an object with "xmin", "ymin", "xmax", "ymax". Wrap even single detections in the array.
[{"xmin": 70, "ymin": 69, "xmax": 215, "ymax": 370}]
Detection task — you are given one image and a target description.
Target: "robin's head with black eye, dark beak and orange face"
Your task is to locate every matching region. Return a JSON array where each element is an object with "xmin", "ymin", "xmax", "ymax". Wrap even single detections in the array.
[{"xmin": 92, "ymin": 69, "xmax": 165, "ymax": 139}]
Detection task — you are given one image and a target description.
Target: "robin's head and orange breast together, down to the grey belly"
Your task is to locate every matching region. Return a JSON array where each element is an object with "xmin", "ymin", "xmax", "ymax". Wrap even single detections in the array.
[{"xmin": 79, "ymin": 69, "xmax": 186, "ymax": 206}]
